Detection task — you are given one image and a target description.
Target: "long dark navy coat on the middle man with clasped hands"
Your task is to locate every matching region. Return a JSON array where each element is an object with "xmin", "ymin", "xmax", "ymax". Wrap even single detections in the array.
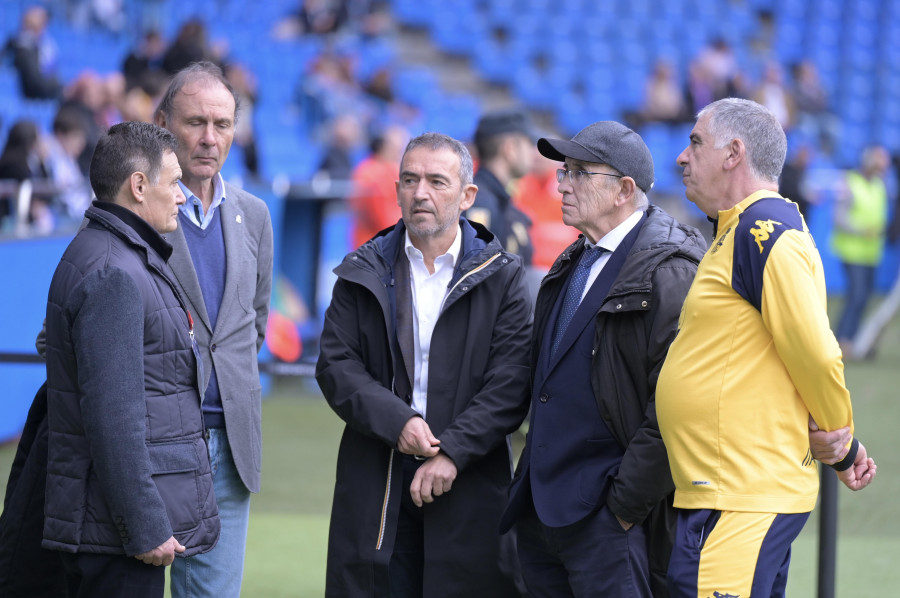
[{"xmin": 316, "ymin": 220, "xmax": 531, "ymax": 598}]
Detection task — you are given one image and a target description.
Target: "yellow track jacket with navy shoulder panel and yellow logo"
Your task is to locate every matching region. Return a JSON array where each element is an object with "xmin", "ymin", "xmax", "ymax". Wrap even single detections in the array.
[{"xmin": 656, "ymin": 191, "xmax": 853, "ymax": 513}]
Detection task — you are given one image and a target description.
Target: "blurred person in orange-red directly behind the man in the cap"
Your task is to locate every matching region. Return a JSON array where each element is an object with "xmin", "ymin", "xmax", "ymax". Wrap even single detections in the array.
[{"xmin": 513, "ymin": 145, "xmax": 578, "ymax": 272}]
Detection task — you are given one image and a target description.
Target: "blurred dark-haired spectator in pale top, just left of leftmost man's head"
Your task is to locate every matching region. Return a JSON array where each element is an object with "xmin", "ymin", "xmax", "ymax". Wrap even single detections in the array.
[{"xmin": 44, "ymin": 107, "xmax": 92, "ymax": 224}]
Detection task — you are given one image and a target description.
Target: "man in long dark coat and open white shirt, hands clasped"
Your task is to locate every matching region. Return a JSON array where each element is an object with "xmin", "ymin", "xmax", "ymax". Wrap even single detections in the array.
[{"xmin": 316, "ymin": 133, "xmax": 531, "ymax": 598}]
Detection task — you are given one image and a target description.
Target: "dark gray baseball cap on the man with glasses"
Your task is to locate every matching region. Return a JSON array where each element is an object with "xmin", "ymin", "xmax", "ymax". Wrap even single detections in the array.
[{"xmin": 538, "ymin": 120, "xmax": 653, "ymax": 192}]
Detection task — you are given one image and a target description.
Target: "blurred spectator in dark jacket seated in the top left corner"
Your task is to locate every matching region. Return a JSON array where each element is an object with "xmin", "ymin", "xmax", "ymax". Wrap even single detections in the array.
[{"xmin": 6, "ymin": 6, "xmax": 62, "ymax": 100}]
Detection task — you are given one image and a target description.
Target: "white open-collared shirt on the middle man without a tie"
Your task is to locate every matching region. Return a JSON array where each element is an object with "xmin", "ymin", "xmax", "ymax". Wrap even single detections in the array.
[{"xmin": 404, "ymin": 227, "xmax": 462, "ymax": 418}]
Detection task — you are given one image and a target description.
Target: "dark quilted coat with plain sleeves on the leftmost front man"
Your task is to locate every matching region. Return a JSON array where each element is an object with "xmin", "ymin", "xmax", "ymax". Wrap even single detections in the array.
[{"xmin": 43, "ymin": 202, "xmax": 219, "ymax": 556}]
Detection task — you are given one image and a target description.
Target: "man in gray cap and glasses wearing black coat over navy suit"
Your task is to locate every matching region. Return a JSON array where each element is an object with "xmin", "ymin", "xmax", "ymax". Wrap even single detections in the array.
[{"xmin": 501, "ymin": 121, "xmax": 706, "ymax": 598}]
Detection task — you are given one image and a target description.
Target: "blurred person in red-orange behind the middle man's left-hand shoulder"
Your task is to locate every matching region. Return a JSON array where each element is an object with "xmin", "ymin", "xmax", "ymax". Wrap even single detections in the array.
[{"xmin": 350, "ymin": 125, "xmax": 409, "ymax": 248}]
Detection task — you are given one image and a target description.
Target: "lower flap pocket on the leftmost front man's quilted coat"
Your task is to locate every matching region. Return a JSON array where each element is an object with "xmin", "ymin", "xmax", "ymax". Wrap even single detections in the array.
[{"xmin": 147, "ymin": 441, "xmax": 204, "ymax": 532}]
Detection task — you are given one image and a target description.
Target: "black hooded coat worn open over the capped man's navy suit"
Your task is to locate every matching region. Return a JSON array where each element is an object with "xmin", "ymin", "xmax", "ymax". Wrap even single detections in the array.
[{"xmin": 532, "ymin": 206, "xmax": 706, "ymax": 596}]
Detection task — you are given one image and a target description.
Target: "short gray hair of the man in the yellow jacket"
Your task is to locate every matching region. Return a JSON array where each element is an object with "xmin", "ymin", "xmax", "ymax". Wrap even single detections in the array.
[{"xmin": 697, "ymin": 98, "xmax": 787, "ymax": 183}]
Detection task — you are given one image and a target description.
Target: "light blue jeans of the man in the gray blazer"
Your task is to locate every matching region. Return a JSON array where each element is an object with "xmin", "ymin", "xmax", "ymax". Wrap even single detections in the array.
[{"xmin": 171, "ymin": 428, "xmax": 250, "ymax": 598}]
